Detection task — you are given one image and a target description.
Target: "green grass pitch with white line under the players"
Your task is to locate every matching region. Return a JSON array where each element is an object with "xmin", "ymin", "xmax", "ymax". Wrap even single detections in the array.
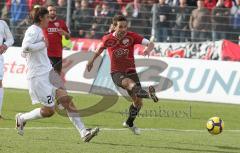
[{"xmin": 0, "ymin": 89, "xmax": 240, "ymax": 153}]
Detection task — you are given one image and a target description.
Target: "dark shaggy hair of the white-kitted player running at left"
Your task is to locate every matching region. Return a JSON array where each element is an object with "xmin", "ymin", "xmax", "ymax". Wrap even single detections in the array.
[{"xmin": 30, "ymin": 7, "xmax": 48, "ymax": 23}]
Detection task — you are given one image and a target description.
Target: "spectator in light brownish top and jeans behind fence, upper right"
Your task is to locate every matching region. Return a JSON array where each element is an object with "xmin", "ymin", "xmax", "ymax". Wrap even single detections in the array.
[{"xmin": 189, "ymin": 0, "xmax": 211, "ymax": 42}]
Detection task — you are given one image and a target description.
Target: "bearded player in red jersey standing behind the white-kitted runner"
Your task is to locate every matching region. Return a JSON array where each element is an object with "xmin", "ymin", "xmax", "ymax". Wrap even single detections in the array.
[{"xmin": 44, "ymin": 5, "xmax": 70, "ymax": 74}]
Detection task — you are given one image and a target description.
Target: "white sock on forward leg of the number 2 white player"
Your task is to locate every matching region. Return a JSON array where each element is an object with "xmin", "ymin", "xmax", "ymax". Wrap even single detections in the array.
[{"xmin": 67, "ymin": 111, "xmax": 87, "ymax": 137}]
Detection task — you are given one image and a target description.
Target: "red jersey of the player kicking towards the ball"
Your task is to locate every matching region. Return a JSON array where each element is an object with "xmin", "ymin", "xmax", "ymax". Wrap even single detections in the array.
[{"xmin": 102, "ymin": 32, "xmax": 143, "ymax": 73}]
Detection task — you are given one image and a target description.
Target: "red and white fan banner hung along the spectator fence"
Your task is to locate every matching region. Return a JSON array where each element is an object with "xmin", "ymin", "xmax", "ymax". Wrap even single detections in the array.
[{"xmin": 71, "ymin": 38, "xmax": 223, "ymax": 60}]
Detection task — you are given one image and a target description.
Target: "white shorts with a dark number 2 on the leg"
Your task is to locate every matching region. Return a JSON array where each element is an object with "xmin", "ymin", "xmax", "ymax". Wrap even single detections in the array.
[{"xmin": 28, "ymin": 73, "xmax": 57, "ymax": 107}]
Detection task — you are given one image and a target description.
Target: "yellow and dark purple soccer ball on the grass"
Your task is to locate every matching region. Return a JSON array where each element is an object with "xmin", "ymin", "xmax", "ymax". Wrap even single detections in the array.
[{"xmin": 207, "ymin": 117, "xmax": 224, "ymax": 135}]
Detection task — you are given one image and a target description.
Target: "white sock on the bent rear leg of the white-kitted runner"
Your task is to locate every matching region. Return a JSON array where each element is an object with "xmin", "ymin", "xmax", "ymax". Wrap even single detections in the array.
[{"xmin": 20, "ymin": 108, "xmax": 43, "ymax": 122}]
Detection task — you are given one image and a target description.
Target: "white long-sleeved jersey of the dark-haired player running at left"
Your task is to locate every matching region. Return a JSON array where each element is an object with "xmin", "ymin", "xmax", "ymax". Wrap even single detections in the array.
[{"xmin": 22, "ymin": 25, "xmax": 52, "ymax": 79}]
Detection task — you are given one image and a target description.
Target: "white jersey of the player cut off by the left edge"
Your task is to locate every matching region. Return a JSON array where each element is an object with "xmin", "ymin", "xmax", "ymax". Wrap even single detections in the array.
[{"xmin": 0, "ymin": 20, "xmax": 14, "ymax": 47}]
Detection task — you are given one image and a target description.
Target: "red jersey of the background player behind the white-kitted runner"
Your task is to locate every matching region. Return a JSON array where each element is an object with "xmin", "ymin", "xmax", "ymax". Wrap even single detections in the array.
[{"xmin": 44, "ymin": 19, "xmax": 69, "ymax": 57}]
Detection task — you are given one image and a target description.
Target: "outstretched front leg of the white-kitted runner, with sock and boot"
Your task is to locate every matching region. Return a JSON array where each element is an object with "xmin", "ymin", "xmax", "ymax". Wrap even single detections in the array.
[{"xmin": 56, "ymin": 89, "xmax": 99, "ymax": 142}]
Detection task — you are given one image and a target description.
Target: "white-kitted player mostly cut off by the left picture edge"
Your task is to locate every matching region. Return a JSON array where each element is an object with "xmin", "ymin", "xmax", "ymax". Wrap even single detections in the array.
[{"xmin": 0, "ymin": 20, "xmax": 14, "ymax": 119}]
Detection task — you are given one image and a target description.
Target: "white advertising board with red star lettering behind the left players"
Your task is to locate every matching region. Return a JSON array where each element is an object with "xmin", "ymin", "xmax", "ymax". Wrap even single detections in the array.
[{"xmin": 3, "ymin": 47, "xmax": 98, "ymax": 92}]
